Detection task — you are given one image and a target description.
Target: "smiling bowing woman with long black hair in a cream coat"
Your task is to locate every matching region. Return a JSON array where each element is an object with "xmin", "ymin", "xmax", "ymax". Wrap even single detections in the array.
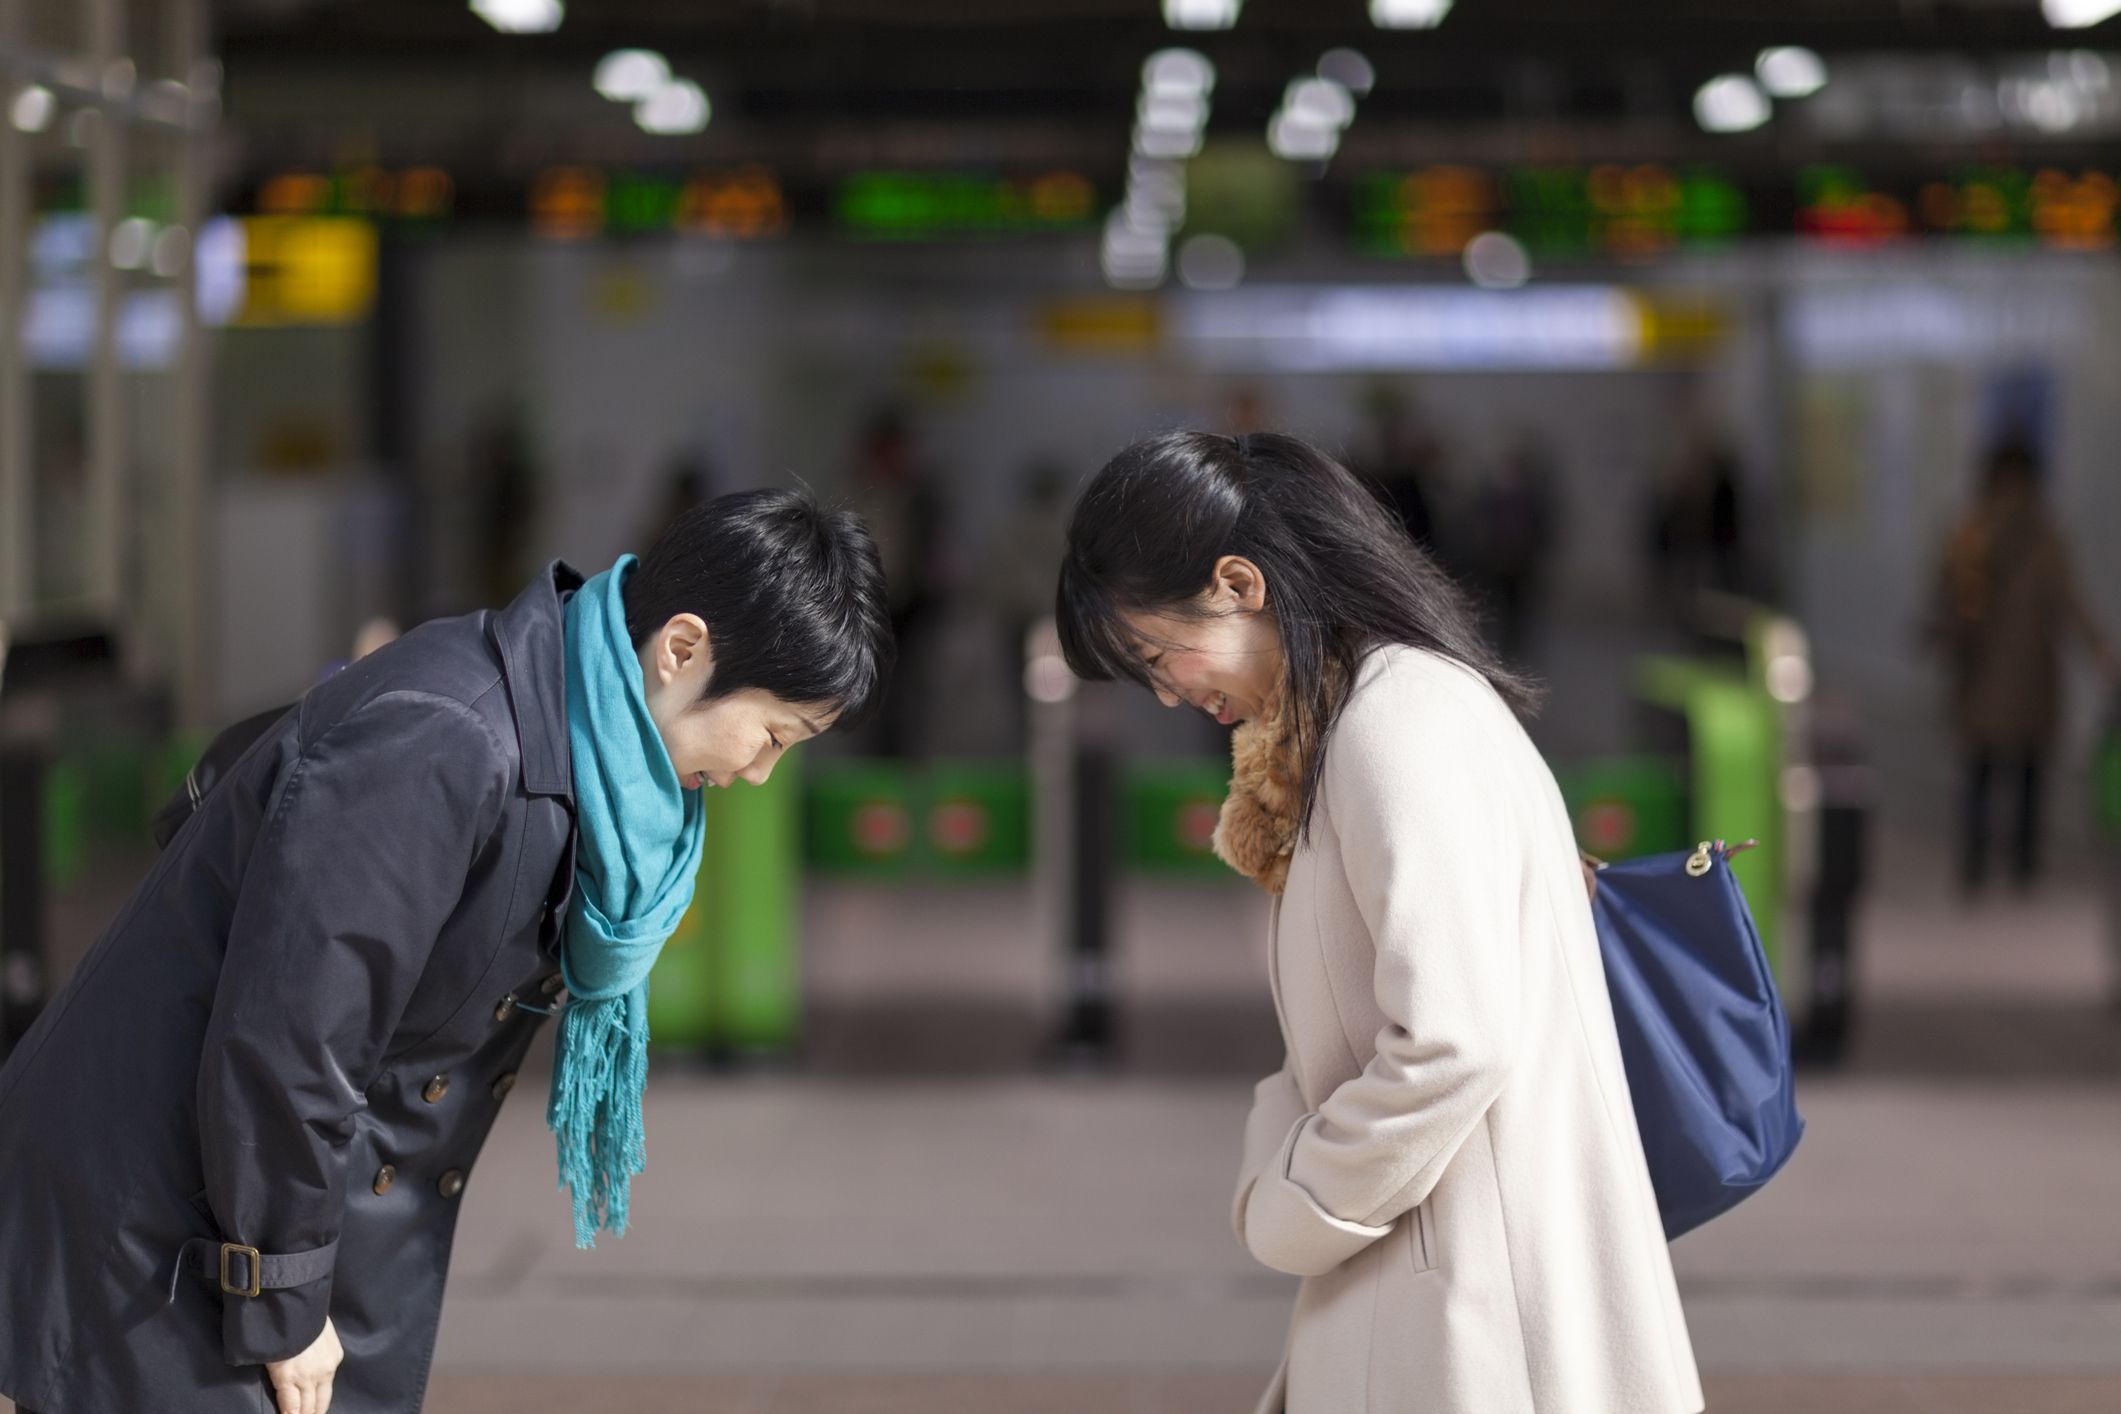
[{"xmin": 1058, "ymin": 432, "xmax": 1701, "ymax": 1414}]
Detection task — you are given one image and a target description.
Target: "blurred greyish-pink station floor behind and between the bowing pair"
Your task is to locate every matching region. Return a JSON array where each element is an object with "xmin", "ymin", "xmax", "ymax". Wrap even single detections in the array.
[{"xmin": 16, "ymin": 818, "xmax": 2121, "ymax": 1414}]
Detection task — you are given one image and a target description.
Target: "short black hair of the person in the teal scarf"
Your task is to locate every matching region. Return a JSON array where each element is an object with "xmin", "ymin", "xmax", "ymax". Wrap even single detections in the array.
[{"xmin": 624, "ymin": 490, "xmax": 895, "ymax": 723}]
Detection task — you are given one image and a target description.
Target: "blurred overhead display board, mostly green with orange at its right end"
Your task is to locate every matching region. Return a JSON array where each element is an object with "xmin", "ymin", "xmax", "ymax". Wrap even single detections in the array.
[{"xmin": 834, "ymin": 172, "xmax": 1097, "ymax": 240}]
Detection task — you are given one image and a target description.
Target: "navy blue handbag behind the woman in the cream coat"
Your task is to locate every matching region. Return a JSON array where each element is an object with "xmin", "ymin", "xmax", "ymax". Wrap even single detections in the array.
[{"xmin": 1591, "ymin": 842, "xmax": 1805, "ymax": 1238}]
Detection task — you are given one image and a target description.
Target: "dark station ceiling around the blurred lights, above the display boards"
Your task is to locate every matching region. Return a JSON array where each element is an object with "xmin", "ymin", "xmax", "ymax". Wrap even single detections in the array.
[{"xmin": 216, "ymin": 0, "xmax": 2121, "ymax": 182}]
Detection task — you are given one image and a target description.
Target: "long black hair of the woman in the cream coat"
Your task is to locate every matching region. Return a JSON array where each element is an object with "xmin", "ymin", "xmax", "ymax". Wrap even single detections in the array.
[{"xmin": 1056, "ymin": 432, "xmax": 1542, "ymax": 833}]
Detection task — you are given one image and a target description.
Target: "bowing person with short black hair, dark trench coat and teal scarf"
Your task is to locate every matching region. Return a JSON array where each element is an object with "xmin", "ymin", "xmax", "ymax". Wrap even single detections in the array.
[{"xmin": 0, "ymin": 492, "xmax": 891, "ymax": 1414}]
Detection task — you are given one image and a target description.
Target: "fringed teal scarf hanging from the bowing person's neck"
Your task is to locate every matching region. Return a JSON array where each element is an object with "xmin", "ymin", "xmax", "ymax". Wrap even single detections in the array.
[{"xmin": 545, "ymin": 555, "xmax": 706, "ymax": 1247}]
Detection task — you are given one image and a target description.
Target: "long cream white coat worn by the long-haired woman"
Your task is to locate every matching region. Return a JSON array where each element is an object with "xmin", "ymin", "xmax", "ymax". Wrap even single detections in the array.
[{"xmin": 1232, "ymin": 647, "xmax": 1701, "ymax": 1414}]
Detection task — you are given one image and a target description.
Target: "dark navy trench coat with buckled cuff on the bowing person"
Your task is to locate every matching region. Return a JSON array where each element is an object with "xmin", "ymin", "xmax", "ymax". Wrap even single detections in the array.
[{"xmin": 0, "ymin": 564, "xmax": 581, "ymax": 1414}]
